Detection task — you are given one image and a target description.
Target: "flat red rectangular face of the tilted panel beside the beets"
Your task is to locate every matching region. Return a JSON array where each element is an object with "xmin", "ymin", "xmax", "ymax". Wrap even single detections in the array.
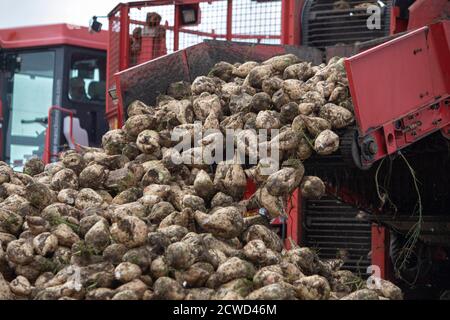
[{"xmin": 347, "ymin": 27, "xmax": 435, "ymax": 135}]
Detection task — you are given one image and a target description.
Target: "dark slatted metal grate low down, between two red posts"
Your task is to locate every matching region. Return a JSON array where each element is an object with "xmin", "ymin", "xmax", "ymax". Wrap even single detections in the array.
[{"xmin": 303, "ymin": 197, "xmax": 371, "ymax": 275}]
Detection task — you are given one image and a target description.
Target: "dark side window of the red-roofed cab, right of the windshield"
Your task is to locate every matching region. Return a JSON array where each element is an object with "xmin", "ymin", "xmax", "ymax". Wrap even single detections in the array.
[{"xmin": 68, "ymin": 53, "xmax": 106, "ymax": 103}]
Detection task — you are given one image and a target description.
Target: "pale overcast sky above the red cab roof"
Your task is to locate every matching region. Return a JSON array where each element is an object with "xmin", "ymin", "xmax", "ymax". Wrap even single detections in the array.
[{"xmin": 0, "ymin": 0, "xmax": 119, "ymax": 28}]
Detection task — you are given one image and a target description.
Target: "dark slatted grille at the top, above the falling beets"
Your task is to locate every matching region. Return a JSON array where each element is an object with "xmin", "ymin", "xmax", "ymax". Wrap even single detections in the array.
[{"xmin": 302, "ymin": 0, "xmax": 391, "ymax": 49}]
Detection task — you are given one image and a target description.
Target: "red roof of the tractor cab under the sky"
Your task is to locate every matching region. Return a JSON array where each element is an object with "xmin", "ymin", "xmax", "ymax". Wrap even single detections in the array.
[{"xmin": 0, "ymin": 24, "xmax": 108, "ymax": 50}]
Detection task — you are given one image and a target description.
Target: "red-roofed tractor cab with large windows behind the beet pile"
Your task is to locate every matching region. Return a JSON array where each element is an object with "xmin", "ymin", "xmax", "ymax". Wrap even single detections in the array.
[{"xmin": 0, "ymin": 24, "xmax": 107, "ymax": 170}]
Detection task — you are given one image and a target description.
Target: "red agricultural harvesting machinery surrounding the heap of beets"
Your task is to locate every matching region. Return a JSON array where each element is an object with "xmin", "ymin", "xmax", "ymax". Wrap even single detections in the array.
[{"xmin": 0, "ymin": 0, "xmax": 450, "ymax": 296}]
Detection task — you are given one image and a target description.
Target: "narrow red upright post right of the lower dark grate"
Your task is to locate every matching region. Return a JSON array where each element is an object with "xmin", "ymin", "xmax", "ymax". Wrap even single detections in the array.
[{"xmin": 372, "ymin": 224, "xmax": 390, "ymax": 279}]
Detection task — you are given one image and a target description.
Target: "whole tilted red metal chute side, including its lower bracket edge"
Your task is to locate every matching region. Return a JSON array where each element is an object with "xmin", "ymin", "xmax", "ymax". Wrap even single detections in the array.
[{"xmin": 345, "ymin": 21, "xmax": 450, "ymax": 168}]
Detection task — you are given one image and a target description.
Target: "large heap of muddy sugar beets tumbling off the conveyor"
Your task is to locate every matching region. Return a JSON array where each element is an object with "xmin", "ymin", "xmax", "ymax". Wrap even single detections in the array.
[{"xmin": 0, "ymin": 54, "xmax": 402, "ymax": 300}]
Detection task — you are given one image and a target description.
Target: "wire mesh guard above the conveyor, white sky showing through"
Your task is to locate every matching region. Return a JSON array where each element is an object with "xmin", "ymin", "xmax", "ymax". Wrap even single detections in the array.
[{"xmin": 125, "ymin": 0, "xmax": 281, "ymax": 54}]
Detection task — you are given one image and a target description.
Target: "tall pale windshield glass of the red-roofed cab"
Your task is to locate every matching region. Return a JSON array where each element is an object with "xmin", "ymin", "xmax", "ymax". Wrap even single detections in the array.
[{"xmin": 5, "ymin": 51, "xmax": 55, "ymax": 170}]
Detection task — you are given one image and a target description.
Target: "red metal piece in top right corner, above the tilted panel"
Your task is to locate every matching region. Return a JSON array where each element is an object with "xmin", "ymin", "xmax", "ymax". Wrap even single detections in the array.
[{"xmin": 408, "ymin": 0, "xmax": 450, "ymax": 30}]
